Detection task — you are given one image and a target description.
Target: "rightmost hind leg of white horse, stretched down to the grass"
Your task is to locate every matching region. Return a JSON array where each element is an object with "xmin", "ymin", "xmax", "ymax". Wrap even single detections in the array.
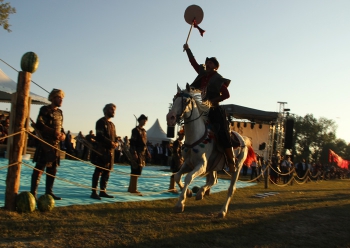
[{"xmin": 218, "ymin": 147, "xmax": 248, "ymax": 218}]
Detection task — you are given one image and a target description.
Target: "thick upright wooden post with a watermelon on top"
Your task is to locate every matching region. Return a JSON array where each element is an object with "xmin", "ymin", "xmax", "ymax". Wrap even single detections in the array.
[{"xmin": 5, "ymin": 71, "xmax": 32, "ymax": 211}]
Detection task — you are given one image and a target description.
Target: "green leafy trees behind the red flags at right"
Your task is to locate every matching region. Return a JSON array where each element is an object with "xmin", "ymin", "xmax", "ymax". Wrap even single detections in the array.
[{"xmin": 293, "ymin": 114, "xmax": 350, "ymax": 164}]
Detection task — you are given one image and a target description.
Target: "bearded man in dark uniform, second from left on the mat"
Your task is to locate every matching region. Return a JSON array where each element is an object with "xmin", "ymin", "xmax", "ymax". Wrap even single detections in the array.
[{"xmin": 90, "ymin": 103, "xmax": 118, "ymax": 200}]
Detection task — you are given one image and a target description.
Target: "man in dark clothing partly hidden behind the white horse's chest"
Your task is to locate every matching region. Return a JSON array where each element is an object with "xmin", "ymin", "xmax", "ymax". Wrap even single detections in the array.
[{"xmin": 169, "ymin": 129, "xmax": 185, "ymax": 193}]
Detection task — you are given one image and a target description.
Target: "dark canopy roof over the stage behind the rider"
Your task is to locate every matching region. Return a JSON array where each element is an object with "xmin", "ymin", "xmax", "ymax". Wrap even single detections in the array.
[{"xmin": 221, "ymin": 104, "xmax": 278, "ymax": 124}]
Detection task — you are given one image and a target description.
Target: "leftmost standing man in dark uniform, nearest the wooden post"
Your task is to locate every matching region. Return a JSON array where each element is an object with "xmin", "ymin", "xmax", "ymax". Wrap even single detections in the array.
[{"xmin": 30, "ymin": 89, "xmax": 66, "ymax": 200}]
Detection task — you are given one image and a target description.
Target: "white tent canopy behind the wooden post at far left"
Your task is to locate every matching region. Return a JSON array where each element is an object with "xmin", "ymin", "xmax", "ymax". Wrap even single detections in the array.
[{"xmin": 0, "ymin": 69, "xmax": 50, "ymax": 105}]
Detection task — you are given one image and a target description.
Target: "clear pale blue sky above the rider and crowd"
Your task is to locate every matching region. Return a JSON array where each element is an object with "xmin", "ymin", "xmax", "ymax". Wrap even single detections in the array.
[{"xmin": 0, "ymin": 0, "xmax": 350, "ymax": 142}]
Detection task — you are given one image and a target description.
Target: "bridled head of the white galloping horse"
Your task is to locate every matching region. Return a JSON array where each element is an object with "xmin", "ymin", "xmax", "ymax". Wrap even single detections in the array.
[{"xmin": 166, "ymin": 84, "xmax": 195, "ymax": 126}]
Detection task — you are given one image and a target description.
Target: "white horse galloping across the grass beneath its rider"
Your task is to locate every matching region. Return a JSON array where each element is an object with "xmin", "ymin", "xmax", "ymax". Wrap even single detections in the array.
[{"xmin": 166, "ymin": 84, "xmax": 255, "ymax": 218}]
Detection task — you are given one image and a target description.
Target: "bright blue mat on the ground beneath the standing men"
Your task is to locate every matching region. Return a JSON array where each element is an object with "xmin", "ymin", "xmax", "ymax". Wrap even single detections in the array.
[{"xmin": 0, "ymin": 158, "xmax": 255, "ymax": 207}]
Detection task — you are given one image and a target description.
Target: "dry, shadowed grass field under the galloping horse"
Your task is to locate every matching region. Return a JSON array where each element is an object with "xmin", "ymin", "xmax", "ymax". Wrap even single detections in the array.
[{"xmin": 0, "ymin": 177, "xmax": 350, "ymax": 248}]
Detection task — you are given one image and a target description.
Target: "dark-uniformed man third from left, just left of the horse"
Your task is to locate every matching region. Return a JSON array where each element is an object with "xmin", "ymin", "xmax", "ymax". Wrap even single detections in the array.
[{"xmin": 128, "ymin": 114, "xmax": 151, "ymax": 196}]
